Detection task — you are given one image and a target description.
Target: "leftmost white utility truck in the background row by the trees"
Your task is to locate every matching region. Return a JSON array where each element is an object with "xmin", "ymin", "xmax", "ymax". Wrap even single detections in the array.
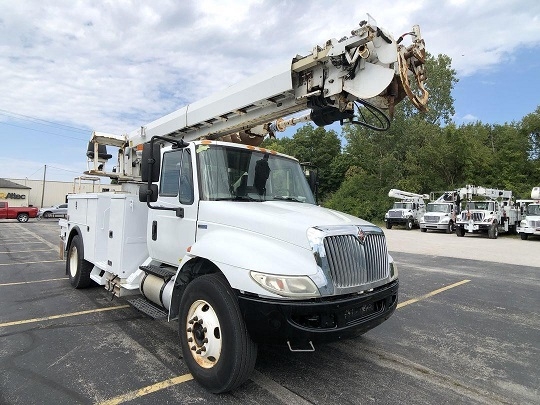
[{"xmin": 384, "ymin": 188, "xmax": 429, "ymax": 230}]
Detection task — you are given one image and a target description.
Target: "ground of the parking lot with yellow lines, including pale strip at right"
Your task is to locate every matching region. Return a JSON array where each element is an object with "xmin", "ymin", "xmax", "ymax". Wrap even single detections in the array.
[{"xmin": 0, "ymin": 219, "xmax": 540, "ymax": 404}]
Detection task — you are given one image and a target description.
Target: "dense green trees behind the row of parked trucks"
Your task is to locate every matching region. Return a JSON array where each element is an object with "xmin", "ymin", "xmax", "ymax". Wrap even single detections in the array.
[{"xmin": 262, "ymin": 55, "xmax": 540, "ymax": 221}]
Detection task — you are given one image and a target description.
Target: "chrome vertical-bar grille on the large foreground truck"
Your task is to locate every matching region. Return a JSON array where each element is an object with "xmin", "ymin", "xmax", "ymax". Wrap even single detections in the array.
[{"xmin": 324, "ymin": 233, "xmax": 389, "ymax": 288}]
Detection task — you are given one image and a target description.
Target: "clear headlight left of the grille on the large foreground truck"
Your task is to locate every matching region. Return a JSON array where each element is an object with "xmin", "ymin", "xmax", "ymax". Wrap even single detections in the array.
[{"xmin": 250, "ymin": 271, "xmax": 321, "ymax": 298}]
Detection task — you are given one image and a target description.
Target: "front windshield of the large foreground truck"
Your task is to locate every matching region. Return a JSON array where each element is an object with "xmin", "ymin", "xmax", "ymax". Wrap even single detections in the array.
[{"xmin": 197, "ymin": 144, "xmax": 315, "ymax": 204}]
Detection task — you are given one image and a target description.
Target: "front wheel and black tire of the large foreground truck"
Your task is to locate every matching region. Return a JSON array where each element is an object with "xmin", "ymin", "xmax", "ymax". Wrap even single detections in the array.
[{"xmin": 178, "ymin": 273, "xmax": 257, "ymax": 394}]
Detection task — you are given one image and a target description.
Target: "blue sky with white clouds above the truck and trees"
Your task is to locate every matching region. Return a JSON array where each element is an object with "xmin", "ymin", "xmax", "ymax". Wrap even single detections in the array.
[{"xmin": 0, "ymin": 0, "xmax": 540, "ymax": 182}]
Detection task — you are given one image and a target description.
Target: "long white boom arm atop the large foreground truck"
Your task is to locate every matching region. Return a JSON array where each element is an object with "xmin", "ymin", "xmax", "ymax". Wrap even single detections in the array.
[{"xmin": 89, "ymin": 15, "xmax": 428, "ymax": 177}]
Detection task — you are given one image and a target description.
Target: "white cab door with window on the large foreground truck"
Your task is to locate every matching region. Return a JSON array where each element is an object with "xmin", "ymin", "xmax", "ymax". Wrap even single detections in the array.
[{"xmin": 148, "ymin": 147, "xmax": 198, "ymax": 266}]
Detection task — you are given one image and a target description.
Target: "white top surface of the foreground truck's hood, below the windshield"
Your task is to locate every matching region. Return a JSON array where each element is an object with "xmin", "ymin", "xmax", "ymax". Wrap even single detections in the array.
[{"xmin": 198, "ymin": 201, "xmax": 373, "ymax": 249}]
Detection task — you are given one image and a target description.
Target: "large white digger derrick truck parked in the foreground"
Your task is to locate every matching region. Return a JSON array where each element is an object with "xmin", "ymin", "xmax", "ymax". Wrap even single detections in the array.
[{"xmin": 60, "ymin": 18, "xmax": 428, "ymax": 393}]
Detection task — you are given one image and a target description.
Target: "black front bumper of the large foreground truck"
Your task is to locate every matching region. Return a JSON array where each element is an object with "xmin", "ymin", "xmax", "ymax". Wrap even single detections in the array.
[{"xmin": 238, "ymin": 280, "xmax": 399, "ymax": 346}]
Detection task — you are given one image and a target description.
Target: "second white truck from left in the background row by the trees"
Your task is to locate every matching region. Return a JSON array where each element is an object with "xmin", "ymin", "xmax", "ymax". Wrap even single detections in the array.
[{"xmin": 420, "ymin": 191, "xmax": 459, "ymax": 233}]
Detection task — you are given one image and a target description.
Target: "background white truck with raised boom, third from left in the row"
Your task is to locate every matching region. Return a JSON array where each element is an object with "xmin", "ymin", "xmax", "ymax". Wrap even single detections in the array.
[{"xmin": 456, "ymin": 185, "xmax": 521, "ymax": 239}]
